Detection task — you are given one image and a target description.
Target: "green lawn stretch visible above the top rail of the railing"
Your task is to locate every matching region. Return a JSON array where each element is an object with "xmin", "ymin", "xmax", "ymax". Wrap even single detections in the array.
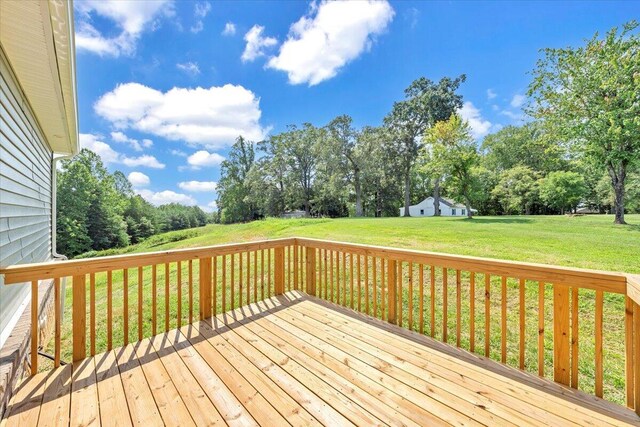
[{"xmin": 92, "ymin": 215, "xmax": 640, "ymax": 273}]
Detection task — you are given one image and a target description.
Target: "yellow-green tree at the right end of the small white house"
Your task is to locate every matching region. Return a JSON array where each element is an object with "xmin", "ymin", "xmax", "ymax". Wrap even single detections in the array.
[{"xmin": 424, "ymin": 114, "xmax": 478, "ymax": 218}]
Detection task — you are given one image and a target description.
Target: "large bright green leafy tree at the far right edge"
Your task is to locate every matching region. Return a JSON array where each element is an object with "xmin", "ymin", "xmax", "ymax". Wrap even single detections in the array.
[{"xmin": 528, "ymin": 21, "xmax": 640, "ymax": 224}]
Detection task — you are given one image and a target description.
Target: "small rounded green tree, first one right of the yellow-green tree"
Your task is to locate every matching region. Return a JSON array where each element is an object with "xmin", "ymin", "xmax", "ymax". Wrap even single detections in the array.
[{"xmin": 492, "ymin": 166, "xmax": 540, "ymax": 215}]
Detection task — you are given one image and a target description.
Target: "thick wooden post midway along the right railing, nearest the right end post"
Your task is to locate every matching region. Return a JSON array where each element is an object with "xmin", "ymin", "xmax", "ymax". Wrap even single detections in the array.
[{"xmin": 553, "ymin": 283, "xmax": 571, "ymax": 385}]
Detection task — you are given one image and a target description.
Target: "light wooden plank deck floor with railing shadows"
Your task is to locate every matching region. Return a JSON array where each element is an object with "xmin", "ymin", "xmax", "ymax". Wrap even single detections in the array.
[{"xmin": 2, "ymin": 292, "xmax": 640, "ymax": 426}]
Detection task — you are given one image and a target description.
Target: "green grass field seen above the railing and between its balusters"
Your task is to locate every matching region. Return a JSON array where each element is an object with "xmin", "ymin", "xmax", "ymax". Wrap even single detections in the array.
[{"xmin": 51, "ymin": 215, "xmax": 640, "ymax": 403}]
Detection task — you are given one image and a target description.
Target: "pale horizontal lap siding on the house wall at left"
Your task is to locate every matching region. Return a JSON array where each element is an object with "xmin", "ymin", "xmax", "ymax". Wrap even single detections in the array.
[{"xmin": 0, "ymin": 50, "xmax": 52, "ymax": 346}]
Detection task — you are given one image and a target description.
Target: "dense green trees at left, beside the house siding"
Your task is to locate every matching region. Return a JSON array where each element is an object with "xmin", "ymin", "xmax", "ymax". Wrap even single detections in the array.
[{"xmin": 56, "ymin": 149, "xmax": 211, "ymax": 257}]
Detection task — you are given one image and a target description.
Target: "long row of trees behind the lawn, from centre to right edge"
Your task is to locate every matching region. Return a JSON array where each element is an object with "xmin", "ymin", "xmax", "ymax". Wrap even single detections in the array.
[{"xmin": 217, "ymin": 21, "xmax": 640, "ymax": 224}]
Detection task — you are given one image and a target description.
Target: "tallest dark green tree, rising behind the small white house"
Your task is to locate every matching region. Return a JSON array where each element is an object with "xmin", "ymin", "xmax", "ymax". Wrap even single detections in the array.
[{"xmin": 384, "ymin": 74, "xmax": 466, "ymax": 216}]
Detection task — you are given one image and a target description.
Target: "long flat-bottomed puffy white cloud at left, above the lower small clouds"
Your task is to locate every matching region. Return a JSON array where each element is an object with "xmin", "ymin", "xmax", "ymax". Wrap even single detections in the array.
[{"xmin": 94, "ymin": 83, "xmax": 268, "ymax": 150}]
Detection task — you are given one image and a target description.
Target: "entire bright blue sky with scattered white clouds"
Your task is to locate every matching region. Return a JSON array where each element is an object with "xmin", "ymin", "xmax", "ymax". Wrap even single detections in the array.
[{"xmin": 75, "ymin": 0, "xmax": 640, "ymax": 211}]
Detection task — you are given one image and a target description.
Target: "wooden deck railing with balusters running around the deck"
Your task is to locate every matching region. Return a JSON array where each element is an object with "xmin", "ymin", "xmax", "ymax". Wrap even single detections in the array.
[{"xmin": 0, "ymin": 238, "xmax": 640, "ymax": 415}]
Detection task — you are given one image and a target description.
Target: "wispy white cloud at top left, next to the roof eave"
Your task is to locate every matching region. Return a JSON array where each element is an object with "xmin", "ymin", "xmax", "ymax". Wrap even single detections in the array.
[{"xmin": 74, "ymin": 0, "xmax": 174, "ymax": 57}]
